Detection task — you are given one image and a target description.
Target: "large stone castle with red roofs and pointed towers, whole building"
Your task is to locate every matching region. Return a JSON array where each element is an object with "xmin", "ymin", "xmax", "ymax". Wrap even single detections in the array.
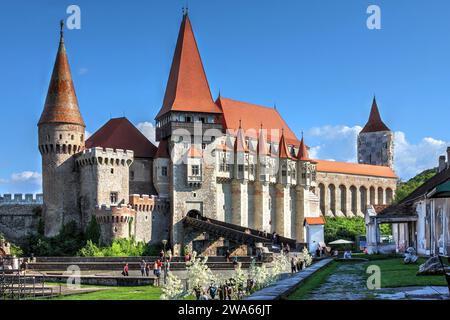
[{"xmin": 34, "ymin": 13, "xmax": 397, "ymax": 253}]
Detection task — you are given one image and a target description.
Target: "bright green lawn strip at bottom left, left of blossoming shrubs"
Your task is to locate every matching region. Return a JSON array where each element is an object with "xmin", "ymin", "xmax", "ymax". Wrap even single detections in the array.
[{"xmin": 53, "ymin": 286, "xmax": 161, "ymax": 300}]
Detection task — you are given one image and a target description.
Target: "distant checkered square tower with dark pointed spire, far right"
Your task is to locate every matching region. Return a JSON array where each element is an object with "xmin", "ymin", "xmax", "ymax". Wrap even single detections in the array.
[{"xmin": 358, "ymin": 97, "xmax": 394, "ymax": 169}]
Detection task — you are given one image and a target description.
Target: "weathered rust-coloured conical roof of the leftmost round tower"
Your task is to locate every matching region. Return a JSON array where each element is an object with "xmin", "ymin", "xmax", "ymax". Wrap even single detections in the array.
[{"xmin": 38, "ymin": 28, "xmax": 85, "ymax": 127}]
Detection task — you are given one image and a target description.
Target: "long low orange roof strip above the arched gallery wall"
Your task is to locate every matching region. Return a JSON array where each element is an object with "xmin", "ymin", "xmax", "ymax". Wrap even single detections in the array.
[{"xmin": 314, "ymin": 160, "xmax": 397, "ymax": 179}]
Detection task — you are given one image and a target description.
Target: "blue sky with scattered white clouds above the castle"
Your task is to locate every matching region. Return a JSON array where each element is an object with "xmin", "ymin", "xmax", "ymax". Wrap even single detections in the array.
[{"xmin": 0, "ymin": 0, "xmax": 450, "ymax": 194}]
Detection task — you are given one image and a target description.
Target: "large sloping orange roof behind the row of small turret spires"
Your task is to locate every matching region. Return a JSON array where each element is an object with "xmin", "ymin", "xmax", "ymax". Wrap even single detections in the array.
[{"xmin": 216, "ymin": 97, "xmax": 300, "ymax": 146}]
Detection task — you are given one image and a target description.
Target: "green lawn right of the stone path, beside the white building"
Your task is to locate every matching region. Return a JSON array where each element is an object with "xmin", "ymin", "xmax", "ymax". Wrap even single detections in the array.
[{"xmin": 368, "ymin": 258, "xmax": 447, "ymax": 288}]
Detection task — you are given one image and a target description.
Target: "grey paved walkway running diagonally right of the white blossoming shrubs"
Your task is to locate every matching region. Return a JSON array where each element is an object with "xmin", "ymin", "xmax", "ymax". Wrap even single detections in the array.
[{"xmin": 244, "ymin": 258, "xmax": 333, "ymax": 300}]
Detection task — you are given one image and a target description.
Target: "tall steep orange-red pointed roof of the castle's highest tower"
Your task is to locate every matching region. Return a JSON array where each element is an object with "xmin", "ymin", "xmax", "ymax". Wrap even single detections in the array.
[{"xmin": 156, "ymin": 14, "xmax": 221, "ymax": 118}]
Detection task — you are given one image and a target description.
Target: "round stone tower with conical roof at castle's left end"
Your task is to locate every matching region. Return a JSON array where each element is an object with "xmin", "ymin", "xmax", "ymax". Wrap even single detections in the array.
[{"xmin": 38, "ymin": 22, "xmax": 85, "ymax": 236}]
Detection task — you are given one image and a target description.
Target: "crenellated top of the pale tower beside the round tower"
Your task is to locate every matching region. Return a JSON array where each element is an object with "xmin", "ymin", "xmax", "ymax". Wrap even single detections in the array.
[{"xmin": 76, "ymin": 147, "xmax": 134, "ymax": 166}]
